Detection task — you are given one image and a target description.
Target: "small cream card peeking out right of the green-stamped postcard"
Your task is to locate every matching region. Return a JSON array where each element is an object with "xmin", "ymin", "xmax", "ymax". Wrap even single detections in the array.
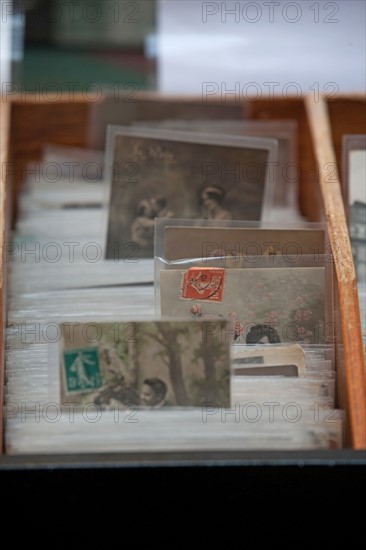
[{"xmin": 232, "ymin": 344, "xmax": 307, "ymax": 377}]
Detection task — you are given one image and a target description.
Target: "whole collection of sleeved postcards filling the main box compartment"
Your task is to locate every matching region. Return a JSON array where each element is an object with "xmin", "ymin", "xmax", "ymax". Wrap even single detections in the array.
[{"xmin": 5, "ymin": 122, "xmax": 344, "ymax": 453}]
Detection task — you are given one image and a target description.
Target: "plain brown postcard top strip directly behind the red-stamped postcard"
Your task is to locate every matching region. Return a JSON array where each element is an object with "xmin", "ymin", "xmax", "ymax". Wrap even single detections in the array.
[{"xmin": 162, "ymin": 226, "xmax": 325, "ymax": 261}]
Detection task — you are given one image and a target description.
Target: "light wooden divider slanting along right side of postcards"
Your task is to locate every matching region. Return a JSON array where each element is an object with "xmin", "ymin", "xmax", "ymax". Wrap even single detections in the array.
[{"xmin": 305, "ymin": 97, "xmax": 366, "ymax": 449}]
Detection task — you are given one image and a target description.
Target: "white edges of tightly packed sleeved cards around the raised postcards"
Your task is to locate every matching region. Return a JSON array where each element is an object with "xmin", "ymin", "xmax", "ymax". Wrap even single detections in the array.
[{"xmin": 5, "ymin": 144, "xmax": 342, "ymax": 454}]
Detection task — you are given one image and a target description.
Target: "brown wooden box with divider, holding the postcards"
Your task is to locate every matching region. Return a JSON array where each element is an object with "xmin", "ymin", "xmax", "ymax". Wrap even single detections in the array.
[{"xmin": 0, "ymin": 94, "xmax": 366, "ymax": 506}]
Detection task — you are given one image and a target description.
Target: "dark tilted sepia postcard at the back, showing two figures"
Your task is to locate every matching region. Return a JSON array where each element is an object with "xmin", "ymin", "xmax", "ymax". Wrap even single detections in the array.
[{"xmin": 106, "ymin": 126, "xmax": 277, "ymax": 259}]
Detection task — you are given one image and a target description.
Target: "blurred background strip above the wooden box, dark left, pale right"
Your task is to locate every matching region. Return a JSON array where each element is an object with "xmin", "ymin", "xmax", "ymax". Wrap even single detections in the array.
[{"xmin": 0, "ymin": 0, "xmax": 366, "ymax": 97}]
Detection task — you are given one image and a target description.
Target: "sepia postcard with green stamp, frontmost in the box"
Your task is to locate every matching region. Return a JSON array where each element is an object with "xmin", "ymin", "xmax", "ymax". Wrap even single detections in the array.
[{"xmin": 59, "ymin": 320, "xmax": 231, "ymax": 409}]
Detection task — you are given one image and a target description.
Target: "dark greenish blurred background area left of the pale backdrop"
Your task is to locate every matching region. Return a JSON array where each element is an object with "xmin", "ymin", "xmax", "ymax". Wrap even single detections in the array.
[{"xmin": 1, "ymin": 0, "xmax": 156, "ymax": 91}]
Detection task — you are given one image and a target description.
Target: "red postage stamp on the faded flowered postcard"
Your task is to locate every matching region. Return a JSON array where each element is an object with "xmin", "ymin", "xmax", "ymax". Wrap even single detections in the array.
[{"xmin": 181, "ymin": 267, "xmax": 225, "ymax": 302}]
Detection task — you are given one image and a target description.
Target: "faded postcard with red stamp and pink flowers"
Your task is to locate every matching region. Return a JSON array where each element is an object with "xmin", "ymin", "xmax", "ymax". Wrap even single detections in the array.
[{"xmin": 160, "ymin": 267, "xmax": 329, "ymax": 344}]
